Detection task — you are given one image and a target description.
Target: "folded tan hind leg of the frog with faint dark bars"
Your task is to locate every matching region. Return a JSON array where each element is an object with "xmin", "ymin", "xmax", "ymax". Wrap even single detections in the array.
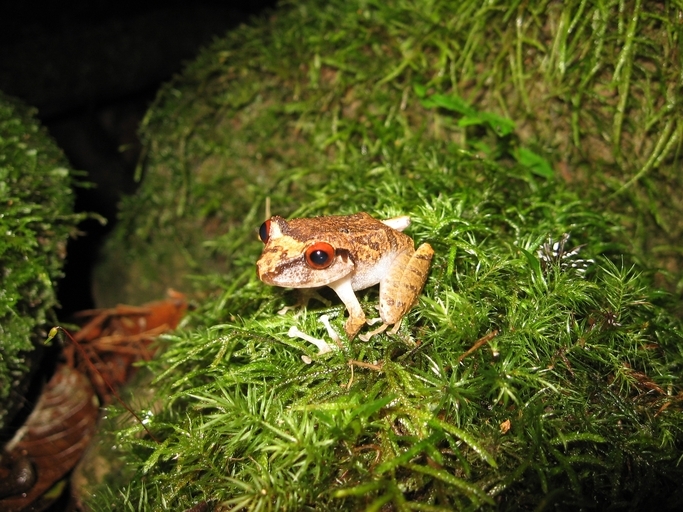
[{"xmin": 379, "ymin": 244, "xmax": 434, "ymax": 326}]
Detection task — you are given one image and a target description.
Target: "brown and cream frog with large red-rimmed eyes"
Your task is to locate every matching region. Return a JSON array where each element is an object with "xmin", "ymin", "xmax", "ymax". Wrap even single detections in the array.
[{"xmin": 256, "ymin": 212, "xmax": 434, "ymax": 340}]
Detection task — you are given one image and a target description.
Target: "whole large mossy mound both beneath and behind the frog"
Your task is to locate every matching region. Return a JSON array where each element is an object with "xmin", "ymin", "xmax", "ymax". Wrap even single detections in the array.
[{"xmin": 94, "ymin": 1, "xmax": 683, "ymax": 510}]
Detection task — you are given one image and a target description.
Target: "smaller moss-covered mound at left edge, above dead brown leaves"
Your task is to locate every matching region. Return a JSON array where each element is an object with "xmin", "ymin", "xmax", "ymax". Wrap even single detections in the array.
[{"xmin": 0, "ymin": 93, "xmax": 80, "ymax": 429}]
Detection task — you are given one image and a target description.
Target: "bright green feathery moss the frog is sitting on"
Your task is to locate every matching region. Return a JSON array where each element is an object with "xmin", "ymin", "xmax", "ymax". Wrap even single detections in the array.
[{"xmin": 92, "ymin": 141, "xmax": 683, "ymax": 510}]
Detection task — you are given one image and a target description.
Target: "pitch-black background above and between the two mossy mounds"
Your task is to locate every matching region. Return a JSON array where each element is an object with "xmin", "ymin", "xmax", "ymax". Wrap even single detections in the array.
[{"xmin": 0, "ymin": 0, "xmax": 276, "ymax": 320}]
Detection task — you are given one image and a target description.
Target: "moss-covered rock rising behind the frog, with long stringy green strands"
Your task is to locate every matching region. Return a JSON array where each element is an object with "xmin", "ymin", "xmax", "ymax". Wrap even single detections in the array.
[{"xmin": 98, "ymin": 0, "xmax": 683, "ymax": 304}]
